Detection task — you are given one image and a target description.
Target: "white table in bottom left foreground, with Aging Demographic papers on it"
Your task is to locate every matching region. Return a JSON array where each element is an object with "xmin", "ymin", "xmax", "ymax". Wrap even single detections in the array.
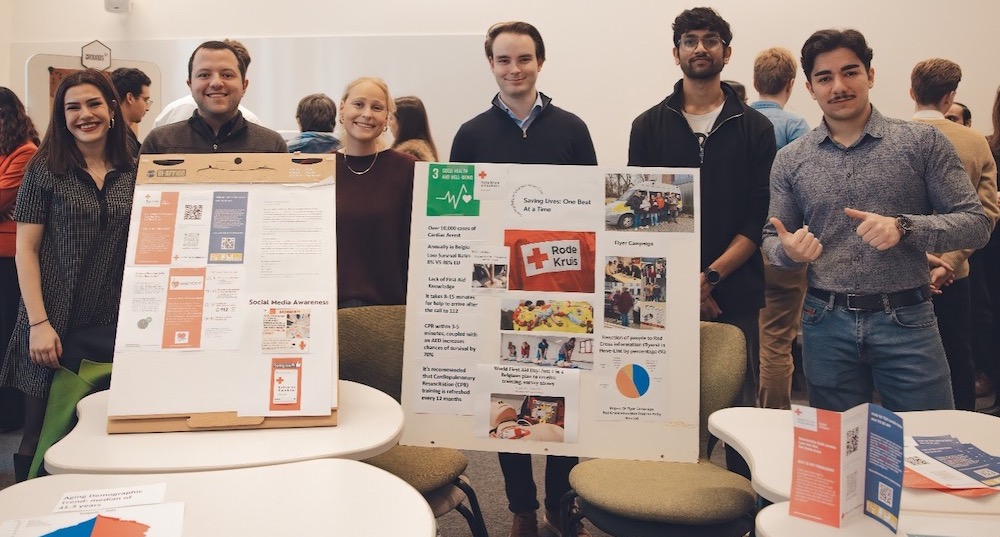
[{"xmin": 0, "ymin": 456, "xmax": 437, "ymax": 537}]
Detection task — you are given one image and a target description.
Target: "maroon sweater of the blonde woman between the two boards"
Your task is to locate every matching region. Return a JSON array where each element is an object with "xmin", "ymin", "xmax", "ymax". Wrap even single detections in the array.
[{"xmin": 337, "ymin": 149, "xmax": 415, "ymax": 304}]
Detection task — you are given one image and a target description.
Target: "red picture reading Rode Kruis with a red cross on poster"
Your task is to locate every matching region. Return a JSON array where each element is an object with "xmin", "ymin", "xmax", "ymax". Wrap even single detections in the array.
[{"xmin": 504, "ymin": 229, "xmax": 596, "ymax": 293}]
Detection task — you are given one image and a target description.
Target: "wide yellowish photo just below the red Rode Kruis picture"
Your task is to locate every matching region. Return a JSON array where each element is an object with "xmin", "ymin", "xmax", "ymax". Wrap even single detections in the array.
[{"xmin": 500, "ymin": 298, "xmax": 594, "ymax": 334}]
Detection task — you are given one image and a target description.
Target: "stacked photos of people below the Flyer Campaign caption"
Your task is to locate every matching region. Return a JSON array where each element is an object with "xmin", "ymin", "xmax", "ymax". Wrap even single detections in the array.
[{"xmin": 604, "ymin": 256, "xmax": 667, "ymax": 329}]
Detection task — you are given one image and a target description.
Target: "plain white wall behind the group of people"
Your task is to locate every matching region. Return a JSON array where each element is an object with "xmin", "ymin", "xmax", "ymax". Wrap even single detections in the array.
[{"xmin": 7, "ymin": 0, "xmax": 1000, "ymax": 165}]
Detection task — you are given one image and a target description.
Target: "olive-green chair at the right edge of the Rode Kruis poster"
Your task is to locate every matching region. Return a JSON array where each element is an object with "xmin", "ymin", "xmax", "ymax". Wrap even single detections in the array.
[{"xmin": 563, "ymin": 322, "xmax": 755, "ymax": 537}]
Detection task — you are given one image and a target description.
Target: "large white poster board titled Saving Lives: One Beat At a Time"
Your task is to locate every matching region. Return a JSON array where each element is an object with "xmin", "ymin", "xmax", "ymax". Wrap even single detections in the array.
[{"xmin": 402, "ymin": 163, "xmax": 700, "ymax": 461}]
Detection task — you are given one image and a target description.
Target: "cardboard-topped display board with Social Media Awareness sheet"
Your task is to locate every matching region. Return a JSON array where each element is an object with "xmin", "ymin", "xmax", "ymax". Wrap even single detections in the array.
[{"xmin": 108, "ymin": 154, "xmax": 338, "ymax": 433}]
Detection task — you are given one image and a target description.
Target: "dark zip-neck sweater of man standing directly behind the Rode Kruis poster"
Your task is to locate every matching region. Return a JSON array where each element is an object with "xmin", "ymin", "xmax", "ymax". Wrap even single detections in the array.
[{"xmin": 450, "ymin": 94, "xmax": 597, "ymax": 166}]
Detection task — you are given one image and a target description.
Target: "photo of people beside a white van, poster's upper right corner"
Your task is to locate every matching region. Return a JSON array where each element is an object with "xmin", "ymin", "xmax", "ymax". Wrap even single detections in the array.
[{"xmin": 604, "ymin": 173, "xmax": 697, "ymax": 233}]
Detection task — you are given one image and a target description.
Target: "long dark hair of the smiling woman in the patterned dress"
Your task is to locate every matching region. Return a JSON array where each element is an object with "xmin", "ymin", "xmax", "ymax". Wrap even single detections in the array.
[{"xmin": 32, "ymin": 69, "xmax": 135, "ymax": 175}]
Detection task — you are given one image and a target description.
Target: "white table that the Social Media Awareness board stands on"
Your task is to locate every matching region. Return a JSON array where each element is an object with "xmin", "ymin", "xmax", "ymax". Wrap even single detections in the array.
[{"xmin": 45, "ymin": 380, "xmax": 403, "ymax": 474}]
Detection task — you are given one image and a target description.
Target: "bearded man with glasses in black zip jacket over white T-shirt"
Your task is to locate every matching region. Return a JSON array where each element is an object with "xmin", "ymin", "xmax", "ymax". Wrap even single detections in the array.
[{"xmin": 628, "ymin": 7, "xmax": 775, "ymax": 473}]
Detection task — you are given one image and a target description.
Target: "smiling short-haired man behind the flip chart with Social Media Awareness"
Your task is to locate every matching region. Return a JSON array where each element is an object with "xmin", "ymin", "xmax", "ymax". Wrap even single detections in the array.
[{"xmin": 141, "ymin": 41, "xmax": 288, "ymax": 154}]
